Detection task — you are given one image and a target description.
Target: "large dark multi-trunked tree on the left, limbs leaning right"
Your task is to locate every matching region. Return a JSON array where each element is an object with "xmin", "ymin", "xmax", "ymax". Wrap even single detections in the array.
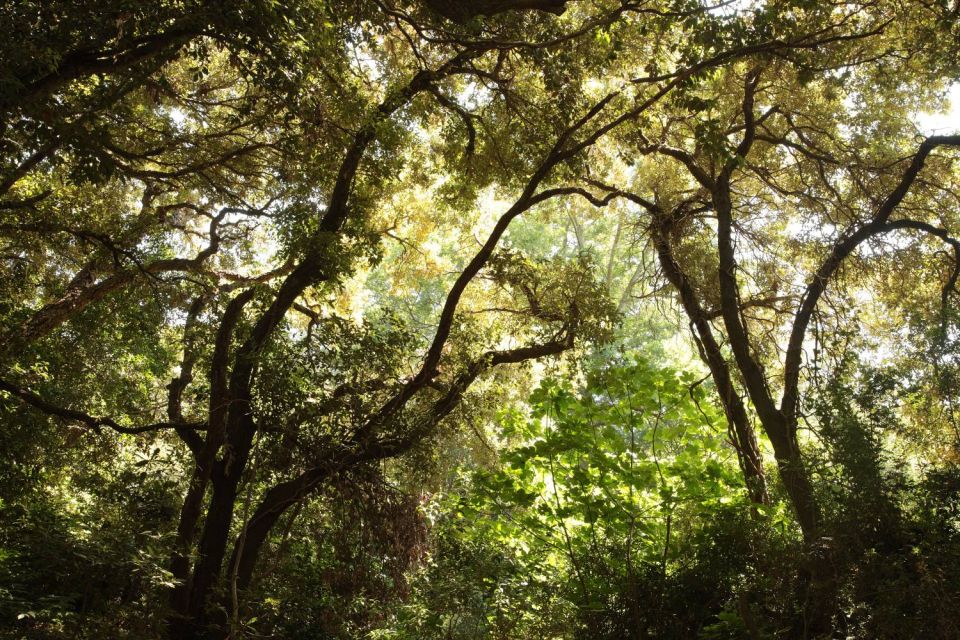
[{"xmin": 3, "ymin": 5, "xmax": 632, "ymax": 637}]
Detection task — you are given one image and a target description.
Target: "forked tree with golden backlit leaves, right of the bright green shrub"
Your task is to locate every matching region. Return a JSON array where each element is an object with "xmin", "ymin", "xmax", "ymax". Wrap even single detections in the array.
[{"xmin": 580, "ymin": 0, "xmax": 960, "ymax": 633}]
